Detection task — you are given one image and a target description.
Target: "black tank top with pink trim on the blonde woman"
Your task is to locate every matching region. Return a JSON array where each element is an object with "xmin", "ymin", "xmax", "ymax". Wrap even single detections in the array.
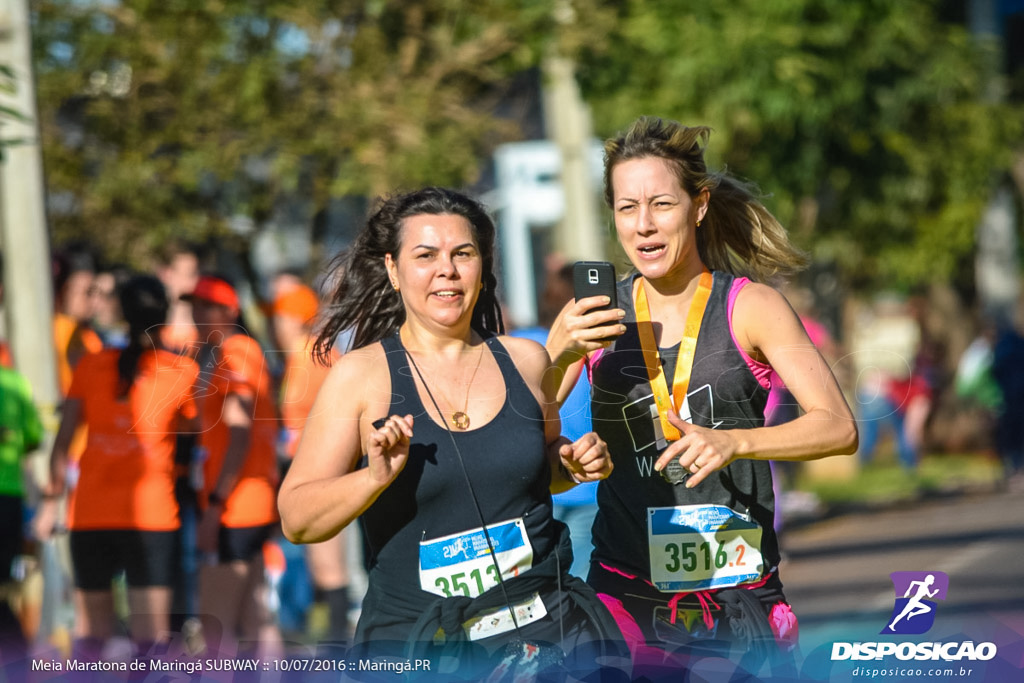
[{"xmin": 592, "ymin": 271, "xmax": 779, "ymax": 580}]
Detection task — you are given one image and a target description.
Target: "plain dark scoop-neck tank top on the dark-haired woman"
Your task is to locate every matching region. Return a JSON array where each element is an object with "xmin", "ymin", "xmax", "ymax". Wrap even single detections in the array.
[{"xmin": 356, "ymin": 335, "xmax": 560, "ymax": 641}]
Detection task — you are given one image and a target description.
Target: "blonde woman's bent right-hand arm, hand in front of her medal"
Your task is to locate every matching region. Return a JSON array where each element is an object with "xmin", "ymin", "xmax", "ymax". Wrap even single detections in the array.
[{"xmin": 655, "ymin": 284, "xmax": 857, "ymax": 486}]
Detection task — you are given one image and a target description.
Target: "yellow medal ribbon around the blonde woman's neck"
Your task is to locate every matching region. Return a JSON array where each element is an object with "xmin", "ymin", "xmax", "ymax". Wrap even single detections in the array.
[{"xmin": 633, "ymin": 270, "xmax": 713, "ymax": 441}]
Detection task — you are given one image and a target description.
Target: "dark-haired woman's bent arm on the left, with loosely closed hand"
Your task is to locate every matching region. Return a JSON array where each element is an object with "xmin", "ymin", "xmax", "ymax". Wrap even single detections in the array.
[{"xmin": 278, "ymin": 345, "xmax": 413, "ymax": 543}]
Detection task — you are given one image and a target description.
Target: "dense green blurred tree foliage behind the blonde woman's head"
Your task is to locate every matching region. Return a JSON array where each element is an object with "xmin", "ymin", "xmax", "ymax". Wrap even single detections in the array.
[{"xmin": 579, "ymin": 0, "xmax": 1024, "ymax": 287}]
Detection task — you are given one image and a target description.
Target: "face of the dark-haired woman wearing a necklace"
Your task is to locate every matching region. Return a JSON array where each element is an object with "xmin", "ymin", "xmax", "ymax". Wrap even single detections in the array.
[{"xmin": 385, "ymin": 214, "xmax": 483, "ymax": 326}]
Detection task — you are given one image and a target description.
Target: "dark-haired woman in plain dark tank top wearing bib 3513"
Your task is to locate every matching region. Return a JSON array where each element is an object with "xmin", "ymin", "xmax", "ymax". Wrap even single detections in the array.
[{"xmin": 280, "ymin": 188, "xmax": 622, "ymax": 680}]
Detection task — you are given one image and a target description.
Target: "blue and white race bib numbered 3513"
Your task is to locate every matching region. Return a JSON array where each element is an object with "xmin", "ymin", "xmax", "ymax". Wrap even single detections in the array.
[{"xmin": 420, "ymin": 519, "xmax": 534, "ymax": 598}]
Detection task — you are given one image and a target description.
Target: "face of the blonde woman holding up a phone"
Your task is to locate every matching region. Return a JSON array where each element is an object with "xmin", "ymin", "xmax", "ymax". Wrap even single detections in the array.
[{"xmin": 611, "ymin": 157, "xmax": 709, "ymax": 280}]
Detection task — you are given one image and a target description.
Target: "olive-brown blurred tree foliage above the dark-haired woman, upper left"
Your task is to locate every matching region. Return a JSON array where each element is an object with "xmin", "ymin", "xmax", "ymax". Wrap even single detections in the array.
[{"xmin": 34, "ymin": 0, "xmax": 600, "ymax": 262}]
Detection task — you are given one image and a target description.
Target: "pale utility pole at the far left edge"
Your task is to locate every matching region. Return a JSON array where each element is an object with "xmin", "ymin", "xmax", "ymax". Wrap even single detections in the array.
[{"xmin": 0, "ymin": 0, "xmax": 59, "ymax": 411}]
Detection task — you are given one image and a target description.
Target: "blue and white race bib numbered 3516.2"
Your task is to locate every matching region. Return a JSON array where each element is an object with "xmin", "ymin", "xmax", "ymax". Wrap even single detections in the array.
[{"xmin": 647, "ymin": 505, "xmax": 764, "ymax": 593}]
